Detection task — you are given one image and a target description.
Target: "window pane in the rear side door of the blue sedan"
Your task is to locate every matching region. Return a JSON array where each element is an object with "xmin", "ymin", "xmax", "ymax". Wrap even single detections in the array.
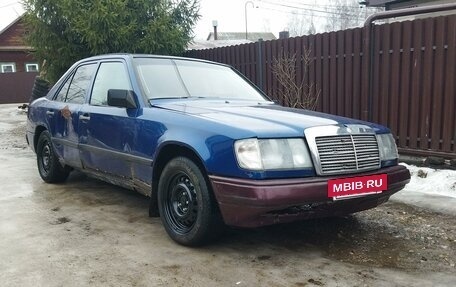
[{"xmin": 62, "ymin": 64, "xmax": 97, "ymax": 104}]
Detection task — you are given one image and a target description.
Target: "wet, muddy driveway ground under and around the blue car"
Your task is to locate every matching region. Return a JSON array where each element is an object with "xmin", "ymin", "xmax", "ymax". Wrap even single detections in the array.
[{"xmin": 0, "ymin": 105, "xmax": 456, "ymax": 286}]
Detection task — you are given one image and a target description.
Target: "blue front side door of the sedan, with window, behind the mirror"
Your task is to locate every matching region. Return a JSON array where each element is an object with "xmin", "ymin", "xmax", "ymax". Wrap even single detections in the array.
[{"xmin": 79, "ymin": 60, "xmax": 139, "ymax": 179}]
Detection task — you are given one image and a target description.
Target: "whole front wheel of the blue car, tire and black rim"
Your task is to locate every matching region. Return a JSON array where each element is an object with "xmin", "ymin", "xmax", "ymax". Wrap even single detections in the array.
[{"xmin": 158, "ymin": 157, "xmax": 224, "ymax": 246}]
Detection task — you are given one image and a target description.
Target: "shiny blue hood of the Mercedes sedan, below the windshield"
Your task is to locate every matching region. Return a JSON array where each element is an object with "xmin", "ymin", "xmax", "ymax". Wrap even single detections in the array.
[{"xmin": 154, "ymin": 100, "xmax": 389, "ymax": 137}]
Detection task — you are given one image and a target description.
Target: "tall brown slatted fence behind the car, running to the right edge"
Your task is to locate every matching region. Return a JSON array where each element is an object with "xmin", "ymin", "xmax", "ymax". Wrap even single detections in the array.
[{"xmin": 186, "ymin": 15, "xmax": 456, "ymax": 158}]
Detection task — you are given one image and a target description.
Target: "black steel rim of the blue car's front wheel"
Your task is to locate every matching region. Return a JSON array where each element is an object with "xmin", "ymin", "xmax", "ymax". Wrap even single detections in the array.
[{"xmin": 164, "ymin": 172, "xmax": 198, "ymax": 234}]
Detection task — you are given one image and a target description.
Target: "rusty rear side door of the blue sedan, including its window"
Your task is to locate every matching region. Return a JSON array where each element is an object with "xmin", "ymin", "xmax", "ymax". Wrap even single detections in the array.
[{"xmin": 46, "ymin": 63, "xmax": 97, "ymax": 167}]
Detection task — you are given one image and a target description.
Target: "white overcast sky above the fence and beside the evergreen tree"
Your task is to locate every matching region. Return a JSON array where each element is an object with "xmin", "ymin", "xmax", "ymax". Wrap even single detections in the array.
[{"xmin": 0, "ymin": 0, "xmax": 366, "ymax": 40}]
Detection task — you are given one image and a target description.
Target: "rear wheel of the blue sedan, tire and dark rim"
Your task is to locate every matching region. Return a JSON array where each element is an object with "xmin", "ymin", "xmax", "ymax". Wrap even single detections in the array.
[{"xmin": 36, "ymin": 131, "xmax": 71, "ymax": 183}]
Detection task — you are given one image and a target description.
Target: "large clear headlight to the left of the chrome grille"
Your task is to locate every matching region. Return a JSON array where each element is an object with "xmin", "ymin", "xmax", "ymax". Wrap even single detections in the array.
[{"xmin": 234, "ymin": 138, "xmax": 313, "ymax": 170}]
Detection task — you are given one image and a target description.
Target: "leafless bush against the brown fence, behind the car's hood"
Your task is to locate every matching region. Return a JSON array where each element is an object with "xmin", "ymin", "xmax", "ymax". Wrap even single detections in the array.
[{"xmin": 272, "ymin": 47, "xmax": 321, "ymax": 110}]
